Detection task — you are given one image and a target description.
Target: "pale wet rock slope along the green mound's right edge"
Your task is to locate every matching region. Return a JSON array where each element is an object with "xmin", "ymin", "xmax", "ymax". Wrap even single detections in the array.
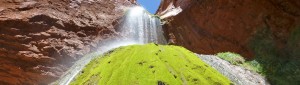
[{"xmin": 196, "ymin": 54, "xmax": 270, "ymax": 85}]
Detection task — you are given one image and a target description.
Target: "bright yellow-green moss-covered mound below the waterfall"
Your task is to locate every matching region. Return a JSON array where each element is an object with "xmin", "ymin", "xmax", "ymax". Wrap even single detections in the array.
[{"xmin": 71, "ymin": 44, "xmax": 231, "ymax": 85}]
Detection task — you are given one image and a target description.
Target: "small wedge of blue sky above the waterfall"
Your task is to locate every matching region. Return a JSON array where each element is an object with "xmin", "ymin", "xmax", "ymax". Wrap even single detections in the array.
[{"xmin": 137, "ymin": 0, "xmax": 161, "ymax": 14}]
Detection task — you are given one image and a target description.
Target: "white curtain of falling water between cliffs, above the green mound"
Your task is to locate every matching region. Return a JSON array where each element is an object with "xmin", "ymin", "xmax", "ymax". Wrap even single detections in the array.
[{"xmin": 118, "ymin": 6, "xmax": 167, "ymax": 44}]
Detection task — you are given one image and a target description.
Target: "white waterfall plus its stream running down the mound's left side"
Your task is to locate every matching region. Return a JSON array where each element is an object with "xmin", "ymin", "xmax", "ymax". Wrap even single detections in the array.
[{"xmin": 55, "ymin": 6, "xmax": 167, "ymax": 85}]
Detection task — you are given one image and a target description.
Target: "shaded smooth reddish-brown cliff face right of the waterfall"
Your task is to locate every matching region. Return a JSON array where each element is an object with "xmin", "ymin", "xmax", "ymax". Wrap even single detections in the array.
[{"xmin": 157, "ymin": 0, "xmax": 300, "ymax": 59}]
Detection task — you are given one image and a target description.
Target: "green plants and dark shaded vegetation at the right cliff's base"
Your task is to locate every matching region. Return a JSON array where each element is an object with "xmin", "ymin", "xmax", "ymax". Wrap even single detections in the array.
[{"xmin": 217, "ymin": 27, "xmax": 300, "ymax": 85}]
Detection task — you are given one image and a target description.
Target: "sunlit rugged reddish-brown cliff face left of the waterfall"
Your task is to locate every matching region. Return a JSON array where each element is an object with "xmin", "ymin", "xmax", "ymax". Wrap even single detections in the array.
[{"xmin": 0, "ymin": 0, "xmax": 135, "ymax": 85}]
